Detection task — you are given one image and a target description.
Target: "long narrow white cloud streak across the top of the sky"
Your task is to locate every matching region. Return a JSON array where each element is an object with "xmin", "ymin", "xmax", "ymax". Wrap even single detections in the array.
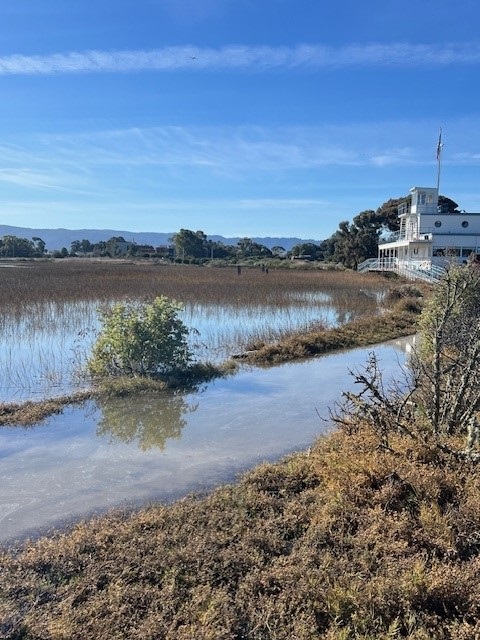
[{"xmin": 0, "ymin": 43, "xmax": 480, "ymax": 75}]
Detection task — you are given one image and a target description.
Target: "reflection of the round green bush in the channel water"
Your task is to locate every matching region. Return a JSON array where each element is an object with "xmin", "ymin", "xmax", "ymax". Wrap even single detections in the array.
[{"xmin": 97, "ymin": 393, "xmax": 198, "ymax": 451}]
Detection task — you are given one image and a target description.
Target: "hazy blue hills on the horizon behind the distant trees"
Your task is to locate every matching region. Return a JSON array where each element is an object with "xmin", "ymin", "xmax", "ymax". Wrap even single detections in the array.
[{"xmin": 0, "ymin": 224, "xmax": 320, "ymax": 251}]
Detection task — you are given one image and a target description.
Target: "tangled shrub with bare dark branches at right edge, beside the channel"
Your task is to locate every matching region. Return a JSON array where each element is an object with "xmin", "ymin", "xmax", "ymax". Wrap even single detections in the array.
[{"xmin": 332, "ymin": 265, "xmax": 480, "ymax": 462}]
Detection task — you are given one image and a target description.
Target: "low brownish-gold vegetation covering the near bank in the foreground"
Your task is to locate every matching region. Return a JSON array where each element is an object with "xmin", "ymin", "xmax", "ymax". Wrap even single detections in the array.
[{"xmin": 0, "ymin": 424, "xmax": 480, "ymax": 640}]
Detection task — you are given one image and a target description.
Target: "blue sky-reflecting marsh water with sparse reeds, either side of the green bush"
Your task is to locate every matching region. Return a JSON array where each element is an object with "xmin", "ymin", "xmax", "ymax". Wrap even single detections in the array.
[{"xmin": 0, "ymin": 293, "xmax": 368, "ymax": 402}]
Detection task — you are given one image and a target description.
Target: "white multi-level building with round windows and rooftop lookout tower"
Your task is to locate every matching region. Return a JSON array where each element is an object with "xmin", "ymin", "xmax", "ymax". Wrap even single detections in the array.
[{"xmin": 378, "ymin": 187, "xmax": 480, "ymax": 270}]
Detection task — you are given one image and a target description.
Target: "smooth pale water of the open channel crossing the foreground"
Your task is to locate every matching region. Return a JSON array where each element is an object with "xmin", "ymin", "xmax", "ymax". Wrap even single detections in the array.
[{"xmin": 0, "ymin": 346, "xmax": 412, "ymax": 540}]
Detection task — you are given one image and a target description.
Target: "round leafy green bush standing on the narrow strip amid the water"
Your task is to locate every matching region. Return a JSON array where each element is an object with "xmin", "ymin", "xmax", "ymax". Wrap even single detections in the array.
[{"xmin": 88, "ymin": 296, "xmax": 192, "ymax": 377}]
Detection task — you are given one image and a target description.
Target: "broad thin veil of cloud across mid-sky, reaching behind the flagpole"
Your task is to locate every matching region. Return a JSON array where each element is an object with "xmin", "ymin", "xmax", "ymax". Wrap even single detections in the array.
[{"xmin": 0, "ymin": 118, "xmax": 480, "ymax": 200}]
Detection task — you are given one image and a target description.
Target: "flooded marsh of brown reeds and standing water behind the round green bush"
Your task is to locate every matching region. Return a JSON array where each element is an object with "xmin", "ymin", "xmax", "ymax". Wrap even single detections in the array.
[{"xmin": 0, "ymin": 260, "xmax": 387, "ymax": 401}]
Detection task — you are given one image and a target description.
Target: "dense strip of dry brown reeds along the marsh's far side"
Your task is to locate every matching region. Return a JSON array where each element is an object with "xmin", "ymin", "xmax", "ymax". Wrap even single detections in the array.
[{"xmin": 0, "ymin": 259, "xmax": 386, "ymax": 311}]
